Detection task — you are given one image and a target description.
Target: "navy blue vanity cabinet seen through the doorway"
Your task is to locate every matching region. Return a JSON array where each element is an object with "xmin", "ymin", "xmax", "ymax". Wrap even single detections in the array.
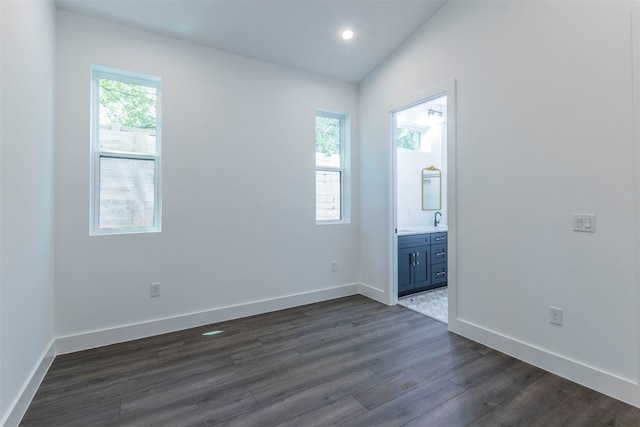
[{"xmin": 398, "ymin": 232, "xmax": 447, "ymax": 296}]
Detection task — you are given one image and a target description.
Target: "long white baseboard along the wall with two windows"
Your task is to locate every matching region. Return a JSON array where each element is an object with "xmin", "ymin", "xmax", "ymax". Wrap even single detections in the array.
[{"xmin": 56, "ymin": 283, "xmax": 359, "ymax": 354}]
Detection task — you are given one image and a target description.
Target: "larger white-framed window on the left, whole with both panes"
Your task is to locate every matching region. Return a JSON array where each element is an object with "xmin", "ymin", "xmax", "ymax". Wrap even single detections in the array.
[{"xmin": 90, "ymin": 66, "xmax": 162, "ymax": 235}]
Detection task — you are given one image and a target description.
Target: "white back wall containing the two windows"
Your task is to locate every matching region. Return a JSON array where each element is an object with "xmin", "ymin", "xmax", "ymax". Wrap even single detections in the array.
[{"xmin": 55, "ymin": 12, "xmax": 359, "ymax": 351}]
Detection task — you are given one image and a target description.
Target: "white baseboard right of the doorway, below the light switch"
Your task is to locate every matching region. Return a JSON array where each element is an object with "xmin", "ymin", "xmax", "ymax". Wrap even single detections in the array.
[{"xmin": 449, "ymin": 319, "xmax": 640, "ymax": 407}]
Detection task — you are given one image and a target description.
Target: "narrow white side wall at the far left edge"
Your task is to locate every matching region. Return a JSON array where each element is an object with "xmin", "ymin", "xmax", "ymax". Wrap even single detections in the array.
[{"xmin": 0, "ymin": 0, "xmax": 55, "ymax": 426}]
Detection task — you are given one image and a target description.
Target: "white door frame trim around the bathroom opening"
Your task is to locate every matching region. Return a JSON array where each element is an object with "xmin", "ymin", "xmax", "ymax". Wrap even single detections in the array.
[{"xmin": 387, "ymin": 80, "xmax": 458, "ymax": 324}]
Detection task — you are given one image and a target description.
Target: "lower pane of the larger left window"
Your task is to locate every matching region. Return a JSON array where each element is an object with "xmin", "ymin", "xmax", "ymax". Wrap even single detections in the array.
[{"xmin": 100, "ymin": 157, "xmax": 155, "ymax": 228}]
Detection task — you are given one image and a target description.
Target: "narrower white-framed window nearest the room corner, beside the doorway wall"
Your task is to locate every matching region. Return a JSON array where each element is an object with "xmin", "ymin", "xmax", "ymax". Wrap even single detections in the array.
[{"xmin": 316, "ymin": 111, "xmax": 349, "ymax": 224}]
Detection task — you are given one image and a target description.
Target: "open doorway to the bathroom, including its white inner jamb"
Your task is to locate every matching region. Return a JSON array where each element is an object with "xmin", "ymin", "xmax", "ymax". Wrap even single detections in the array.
[{"xmin": 391, "ymin": 82, "xmax": 455, "ymax": 323}]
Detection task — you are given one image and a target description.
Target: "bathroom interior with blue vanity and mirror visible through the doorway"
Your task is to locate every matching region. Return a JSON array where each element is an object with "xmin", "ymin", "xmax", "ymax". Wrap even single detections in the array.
[{"xmin": 393, "ymin": 95, "xmax": 448, "ymax": 323}]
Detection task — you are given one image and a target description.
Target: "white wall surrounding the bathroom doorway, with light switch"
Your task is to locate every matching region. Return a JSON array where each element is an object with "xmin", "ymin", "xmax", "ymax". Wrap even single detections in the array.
[{"xmin": 360, "ymin": 1, "xmax": 640, "ymax": 405}]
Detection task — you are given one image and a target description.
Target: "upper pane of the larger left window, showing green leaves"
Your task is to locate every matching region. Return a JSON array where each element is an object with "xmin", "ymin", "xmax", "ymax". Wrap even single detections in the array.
[{"xmin": 99, "ymin": 78, "xmax": 157, "ymax": 154}]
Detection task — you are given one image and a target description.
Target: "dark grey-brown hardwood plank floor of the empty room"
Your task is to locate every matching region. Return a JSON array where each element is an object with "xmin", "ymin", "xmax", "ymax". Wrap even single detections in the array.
[{"xmin": 21, "ymin": 296, "xmax": 640, "ymax": 427}]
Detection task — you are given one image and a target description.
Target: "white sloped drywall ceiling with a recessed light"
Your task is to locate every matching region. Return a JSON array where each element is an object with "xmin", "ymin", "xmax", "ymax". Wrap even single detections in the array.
[{"xmin": 56, "ymin": 0, "xmax": 445, "ymax": 83}]
